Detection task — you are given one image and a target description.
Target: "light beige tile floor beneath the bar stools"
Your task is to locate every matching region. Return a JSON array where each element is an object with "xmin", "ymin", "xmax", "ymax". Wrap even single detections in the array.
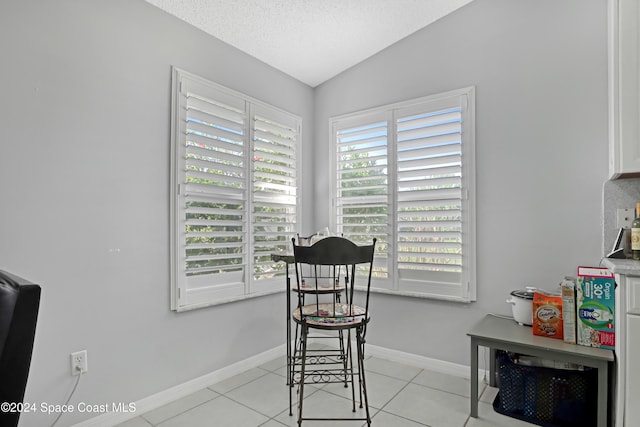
[{"xmin": 118, "ymin": 357, "xmax": 531, "ymax": 427}]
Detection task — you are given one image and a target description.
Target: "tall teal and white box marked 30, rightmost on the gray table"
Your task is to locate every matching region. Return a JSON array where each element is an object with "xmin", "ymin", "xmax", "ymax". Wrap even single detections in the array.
[{"xmin": 576, "ymin": 267, "xmax": 616, "ymax": 349}]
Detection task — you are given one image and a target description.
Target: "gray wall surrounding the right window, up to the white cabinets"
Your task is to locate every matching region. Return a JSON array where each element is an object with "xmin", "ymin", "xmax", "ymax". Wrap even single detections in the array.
[{"xmin": 315, "ymin": 0, "xmax": 607, "ymax": 364}]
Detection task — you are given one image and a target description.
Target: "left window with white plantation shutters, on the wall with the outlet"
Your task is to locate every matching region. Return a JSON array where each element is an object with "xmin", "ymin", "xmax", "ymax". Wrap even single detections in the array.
[{"xmin": 171, "ymin": 69, "xmax": 300, "ymax": 311}]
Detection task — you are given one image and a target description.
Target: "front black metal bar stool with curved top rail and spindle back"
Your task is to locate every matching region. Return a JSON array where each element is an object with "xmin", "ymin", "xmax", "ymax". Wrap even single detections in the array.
[{"xmin": 291, "ymin": 237, "xmax": 376, "ymax": 426}]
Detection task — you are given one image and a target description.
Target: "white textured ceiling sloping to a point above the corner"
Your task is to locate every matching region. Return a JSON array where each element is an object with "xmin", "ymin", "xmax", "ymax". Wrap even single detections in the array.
[{"xmin": 146, "ymin": 0, "xmax": 472, "ymax": 87}]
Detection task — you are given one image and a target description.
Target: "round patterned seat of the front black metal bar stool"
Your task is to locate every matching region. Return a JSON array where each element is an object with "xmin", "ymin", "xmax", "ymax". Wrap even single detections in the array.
[{"xmin": 293, "ymin": 302, "xmax": 369, "ymax": 329}]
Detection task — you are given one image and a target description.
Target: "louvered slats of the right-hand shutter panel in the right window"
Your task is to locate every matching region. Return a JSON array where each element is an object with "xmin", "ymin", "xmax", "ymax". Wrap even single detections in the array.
[{"xmin": 395, "ymin": 98, "xmax": 462, "ymax": 288}]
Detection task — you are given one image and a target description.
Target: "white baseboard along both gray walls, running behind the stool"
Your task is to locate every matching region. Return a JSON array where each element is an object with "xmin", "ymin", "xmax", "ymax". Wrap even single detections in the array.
[{"xmin": 74, "ymin": 344, "xmax": 484, "ymax": 427}]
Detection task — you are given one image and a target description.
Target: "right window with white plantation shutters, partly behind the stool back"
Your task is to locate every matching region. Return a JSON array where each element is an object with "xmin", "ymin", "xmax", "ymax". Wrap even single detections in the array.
[{"xmin": 332, "ymin": 88, "xmax": 475, "ymax": 302}]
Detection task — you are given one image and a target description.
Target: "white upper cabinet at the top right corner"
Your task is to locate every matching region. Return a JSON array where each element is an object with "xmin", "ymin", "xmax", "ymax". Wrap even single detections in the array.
[{"xmin": 608, "ymin": 0, "xmax": 640, "ymax": 178}]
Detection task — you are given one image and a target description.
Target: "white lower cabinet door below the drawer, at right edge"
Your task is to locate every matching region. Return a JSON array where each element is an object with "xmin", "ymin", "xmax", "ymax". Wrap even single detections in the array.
[{"xmin": 624, "ymin": 315, "xmax": 640, "ymax": 426}]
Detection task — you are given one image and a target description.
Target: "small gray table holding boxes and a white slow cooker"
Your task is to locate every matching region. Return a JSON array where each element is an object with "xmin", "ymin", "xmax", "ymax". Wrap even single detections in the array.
[{"xmin": 467, "ymin": 315, "xmax": 614, "ymax": 427}]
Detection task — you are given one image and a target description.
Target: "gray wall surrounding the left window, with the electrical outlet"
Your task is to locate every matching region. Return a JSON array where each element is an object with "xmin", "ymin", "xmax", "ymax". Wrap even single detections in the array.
[{"xmin": 0, "ymin": 0, "xmax": 313, "ymax": 426}]
